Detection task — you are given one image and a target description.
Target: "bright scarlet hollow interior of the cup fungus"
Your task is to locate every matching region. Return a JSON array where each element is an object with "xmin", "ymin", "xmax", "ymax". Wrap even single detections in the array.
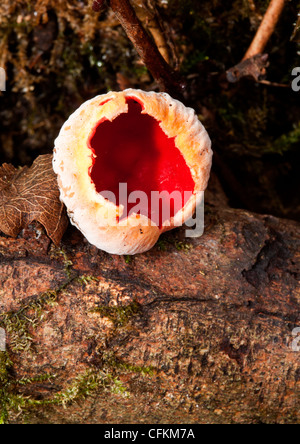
[{"xmin": 88, "ymin": 98, "xmax": 195, "ymax": 226}]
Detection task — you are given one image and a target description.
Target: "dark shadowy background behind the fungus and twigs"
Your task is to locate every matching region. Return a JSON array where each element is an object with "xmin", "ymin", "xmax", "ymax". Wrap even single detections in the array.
[{"xmin": 0, "ymin": 0, "xmax": 300, "ymax": 220}]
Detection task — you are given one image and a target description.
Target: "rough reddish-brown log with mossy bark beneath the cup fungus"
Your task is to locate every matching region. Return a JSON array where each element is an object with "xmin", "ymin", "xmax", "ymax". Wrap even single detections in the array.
[{"xmin": 0, "ymin": 176, "xmax": 300, "ymax": 424}]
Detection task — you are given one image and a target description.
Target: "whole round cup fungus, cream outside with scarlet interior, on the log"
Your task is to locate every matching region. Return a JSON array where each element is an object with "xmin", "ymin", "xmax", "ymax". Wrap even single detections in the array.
[{"xmin": 53, "ymin": 89, "xmax": 212, "ymax": 254}]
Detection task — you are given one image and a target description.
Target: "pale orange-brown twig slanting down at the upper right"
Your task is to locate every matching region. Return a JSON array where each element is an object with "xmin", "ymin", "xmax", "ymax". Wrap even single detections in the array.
[{"xmin": 243, "ymin": 0, "xmax": 285, "ymax": 60}]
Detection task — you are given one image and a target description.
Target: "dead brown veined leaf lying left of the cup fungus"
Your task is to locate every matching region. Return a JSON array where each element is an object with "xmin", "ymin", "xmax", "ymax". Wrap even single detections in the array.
[{"xmin": 0, "ymin": 154, "xmax": 68, "ymax": 245}]
